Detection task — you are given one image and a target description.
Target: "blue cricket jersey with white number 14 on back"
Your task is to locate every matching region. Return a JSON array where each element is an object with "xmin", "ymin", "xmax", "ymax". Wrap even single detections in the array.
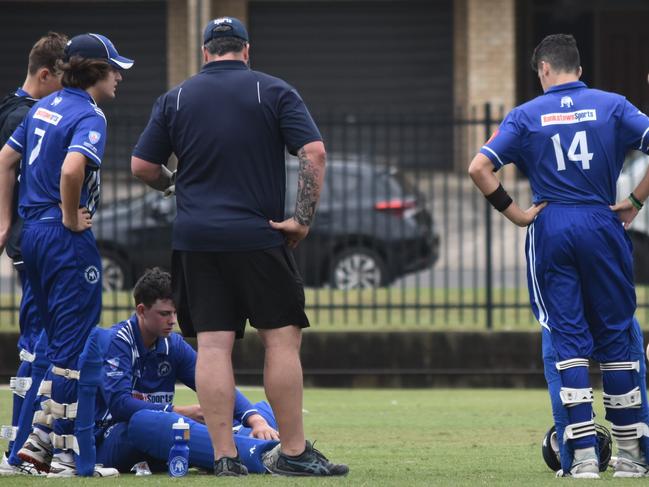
[{"xmin": 480, "ymin": 81, "xmax": 649, "ymax": 205}]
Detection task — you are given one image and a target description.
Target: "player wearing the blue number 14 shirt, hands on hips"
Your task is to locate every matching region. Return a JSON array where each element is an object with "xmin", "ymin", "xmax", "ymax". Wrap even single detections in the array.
[{"xmin": 469, "ymin": 34, "xmax": 649, "ymax": 478}]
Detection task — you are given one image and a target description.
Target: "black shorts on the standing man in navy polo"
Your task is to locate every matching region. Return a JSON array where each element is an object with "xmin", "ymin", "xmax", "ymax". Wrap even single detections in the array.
[{"xmin": 171, "ymin": 246, "xmax": 309, "ymax": 338}]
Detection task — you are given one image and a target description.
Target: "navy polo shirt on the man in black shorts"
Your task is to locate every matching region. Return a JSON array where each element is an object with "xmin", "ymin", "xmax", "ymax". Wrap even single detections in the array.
[{"xmin": 133, "ymin": 61, "xmax": 322, "ymax": 252}]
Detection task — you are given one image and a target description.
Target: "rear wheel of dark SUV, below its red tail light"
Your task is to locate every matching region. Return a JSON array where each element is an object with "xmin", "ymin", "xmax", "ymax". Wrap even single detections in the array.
[{"xmin": 331, "ymin": 247, "xmax": 388, "ymax": 289}]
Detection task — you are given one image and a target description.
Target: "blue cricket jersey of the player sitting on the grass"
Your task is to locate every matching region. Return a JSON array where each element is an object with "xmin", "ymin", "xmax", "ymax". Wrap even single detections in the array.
[{"xmin": 96, "ymin": 315, "xmax": 258, "ymax": 424}]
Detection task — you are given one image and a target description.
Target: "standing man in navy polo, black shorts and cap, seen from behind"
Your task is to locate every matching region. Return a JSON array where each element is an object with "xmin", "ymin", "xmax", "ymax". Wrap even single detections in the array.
[{"xmin": 131, "ymin": 17, "xmax": 348, "ymax": 475}]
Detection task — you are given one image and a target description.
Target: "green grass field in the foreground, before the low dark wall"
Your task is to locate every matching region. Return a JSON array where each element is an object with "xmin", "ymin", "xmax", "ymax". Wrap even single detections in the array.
[{"xmin": 0, "ymin": 388, "xmax": 647, "ymax": 487}]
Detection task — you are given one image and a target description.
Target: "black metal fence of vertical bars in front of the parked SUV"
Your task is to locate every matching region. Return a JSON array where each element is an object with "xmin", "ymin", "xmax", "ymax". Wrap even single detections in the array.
[{"xmin": 0, "ymin": 106, "xmax": 649, "ymax": 330}]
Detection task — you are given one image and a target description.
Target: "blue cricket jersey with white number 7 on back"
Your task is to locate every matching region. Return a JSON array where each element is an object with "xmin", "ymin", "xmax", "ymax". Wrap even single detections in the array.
[{"xmin": 7, "ymin": 88, "xmax": 106, "ymax": 222}]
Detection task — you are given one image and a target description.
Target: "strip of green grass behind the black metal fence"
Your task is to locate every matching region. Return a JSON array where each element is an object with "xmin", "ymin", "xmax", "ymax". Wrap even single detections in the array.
[{"xmin": 0, "ymin": 286, "xmax": 649, "ymax": 333}]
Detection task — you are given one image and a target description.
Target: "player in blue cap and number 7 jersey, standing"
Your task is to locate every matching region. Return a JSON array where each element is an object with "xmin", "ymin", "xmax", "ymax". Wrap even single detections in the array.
[{"xmin": 0, "ymin": 34, "xmax": 133, "ymax": 475}]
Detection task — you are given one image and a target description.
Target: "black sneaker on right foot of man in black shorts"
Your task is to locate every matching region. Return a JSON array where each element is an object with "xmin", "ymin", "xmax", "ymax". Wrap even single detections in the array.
[{"xmin": 263, "ymin": 441, "xmax": 349, "ymax": 477}]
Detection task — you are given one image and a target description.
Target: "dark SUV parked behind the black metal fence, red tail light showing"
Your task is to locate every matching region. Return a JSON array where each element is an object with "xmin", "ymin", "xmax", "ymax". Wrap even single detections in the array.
[{"xmin": 93, "ymin": 162, "xmax": 439, "ymax": 290}]
